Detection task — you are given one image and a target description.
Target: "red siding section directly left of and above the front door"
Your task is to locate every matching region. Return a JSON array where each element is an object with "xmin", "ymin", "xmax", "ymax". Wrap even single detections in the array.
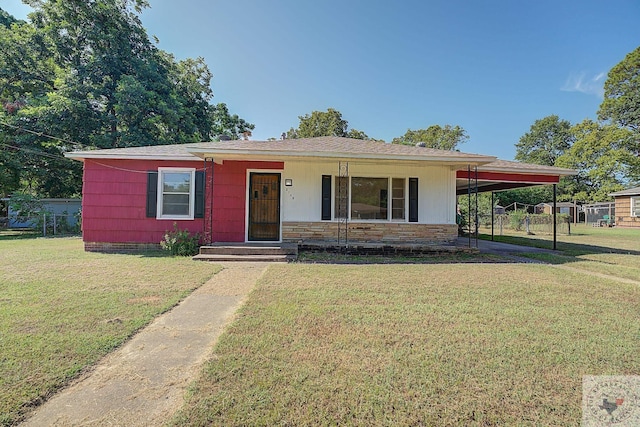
[{"xmin": 212, "ymin": 161, "xmax": 284, "ymax": 242}]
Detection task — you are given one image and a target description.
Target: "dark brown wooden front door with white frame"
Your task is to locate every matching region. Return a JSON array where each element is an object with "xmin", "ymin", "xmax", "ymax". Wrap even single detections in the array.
[{"xmin": 248, "ymin": 172, "xmax": 280, "ymax": 241}]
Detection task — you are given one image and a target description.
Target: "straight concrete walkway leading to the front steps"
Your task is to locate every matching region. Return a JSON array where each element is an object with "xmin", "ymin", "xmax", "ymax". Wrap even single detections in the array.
[{"xmin": 23, "ymin": 262, "xmax": 269, "ymax": 426}]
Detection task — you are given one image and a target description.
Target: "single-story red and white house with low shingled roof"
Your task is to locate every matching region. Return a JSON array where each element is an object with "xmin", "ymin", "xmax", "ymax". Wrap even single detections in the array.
[{"xmin": 67, "ymin": 137, "xmax": 574, "ymax": 250}]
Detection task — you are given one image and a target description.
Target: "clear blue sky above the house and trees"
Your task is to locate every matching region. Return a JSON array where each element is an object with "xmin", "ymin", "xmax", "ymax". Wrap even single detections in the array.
[{"xmin": 0, "ymin": 0, "xmax": 640, "ymax": 159}]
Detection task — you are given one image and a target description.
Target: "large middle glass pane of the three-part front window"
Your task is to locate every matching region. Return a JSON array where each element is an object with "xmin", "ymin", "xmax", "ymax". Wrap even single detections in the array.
[{"xmin": 351, "ymin": 178, "xmax": 389, "ymax": 219}]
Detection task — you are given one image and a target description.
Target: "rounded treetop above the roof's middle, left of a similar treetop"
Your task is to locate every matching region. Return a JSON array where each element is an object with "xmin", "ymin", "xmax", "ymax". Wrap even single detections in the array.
[{"xmin": 285, "ymin": 108, "xmax": 369, "ymax": 139}]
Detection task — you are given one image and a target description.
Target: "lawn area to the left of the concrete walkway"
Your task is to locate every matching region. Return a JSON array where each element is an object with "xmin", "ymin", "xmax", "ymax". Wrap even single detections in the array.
[{"xmin": 0, "ymin": 233, "xmax": 218, "ymax": 425}]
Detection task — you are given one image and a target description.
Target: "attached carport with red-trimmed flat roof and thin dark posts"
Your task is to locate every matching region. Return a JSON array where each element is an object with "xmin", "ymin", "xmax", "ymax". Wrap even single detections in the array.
[{"xmin": 456, "ymin": 160, "xmax": 577, "ymax": 250}]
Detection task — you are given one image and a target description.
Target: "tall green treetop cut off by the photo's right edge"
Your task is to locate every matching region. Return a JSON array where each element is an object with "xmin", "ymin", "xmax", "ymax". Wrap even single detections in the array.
[{"xmin": 598, "ymin": 47, "xmax": 640, "ymax": 133}]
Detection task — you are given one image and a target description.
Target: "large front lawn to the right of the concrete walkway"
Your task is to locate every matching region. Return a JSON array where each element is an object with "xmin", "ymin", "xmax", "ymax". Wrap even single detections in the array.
[{"xmin": 173, "ymin": 264, "xmax": 640, "ymax": 426}]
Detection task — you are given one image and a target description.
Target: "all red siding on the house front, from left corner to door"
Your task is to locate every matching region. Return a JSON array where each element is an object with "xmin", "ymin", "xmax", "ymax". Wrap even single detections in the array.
[{"xmin": 82, "ymin": 159, "xmax": 284, "ymax": 250}]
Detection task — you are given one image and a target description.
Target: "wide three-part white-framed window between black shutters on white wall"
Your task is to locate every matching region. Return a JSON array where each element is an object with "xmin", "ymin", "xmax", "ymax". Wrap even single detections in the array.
[{"xmin": 334, "ymin": 176, "xmax": 406, "ymax": 221}]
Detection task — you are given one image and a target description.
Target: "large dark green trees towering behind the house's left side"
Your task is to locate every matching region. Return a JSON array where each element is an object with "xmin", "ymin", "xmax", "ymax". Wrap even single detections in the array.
[{"xmin": 0, "ymin": 0, "xmax": 254, "ymax": 197}]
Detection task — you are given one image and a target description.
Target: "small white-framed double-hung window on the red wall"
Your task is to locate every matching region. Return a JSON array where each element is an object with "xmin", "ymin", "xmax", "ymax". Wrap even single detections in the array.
[{"xmin": 156, "ymin": 168, "xmax": 196, "ymax": 219}]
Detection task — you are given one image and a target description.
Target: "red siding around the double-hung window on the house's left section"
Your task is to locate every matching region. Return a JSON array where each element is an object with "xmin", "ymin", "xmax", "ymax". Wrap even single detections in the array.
[{"xmin": 82, "ymin": 159, "xmax": 204, "ymax": 247}]
